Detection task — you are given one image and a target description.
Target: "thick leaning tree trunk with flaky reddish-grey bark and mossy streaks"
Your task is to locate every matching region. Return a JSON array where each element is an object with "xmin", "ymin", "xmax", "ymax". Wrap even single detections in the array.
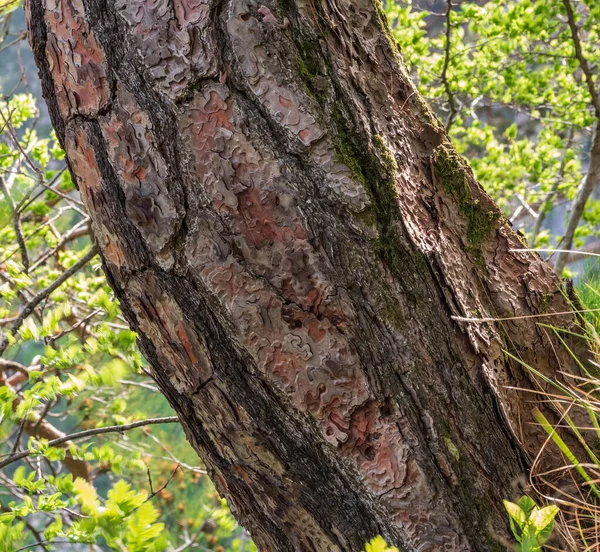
[{"xmin": 27, "ymin": 0, "xmax": 576, "ymax": 551}]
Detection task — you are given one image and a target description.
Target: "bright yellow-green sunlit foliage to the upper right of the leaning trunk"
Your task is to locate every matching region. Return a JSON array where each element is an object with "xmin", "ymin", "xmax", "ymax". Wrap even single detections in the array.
[{"xmin": 387, "ymin": 0, "xmax": 600, "ymax": 245}]
